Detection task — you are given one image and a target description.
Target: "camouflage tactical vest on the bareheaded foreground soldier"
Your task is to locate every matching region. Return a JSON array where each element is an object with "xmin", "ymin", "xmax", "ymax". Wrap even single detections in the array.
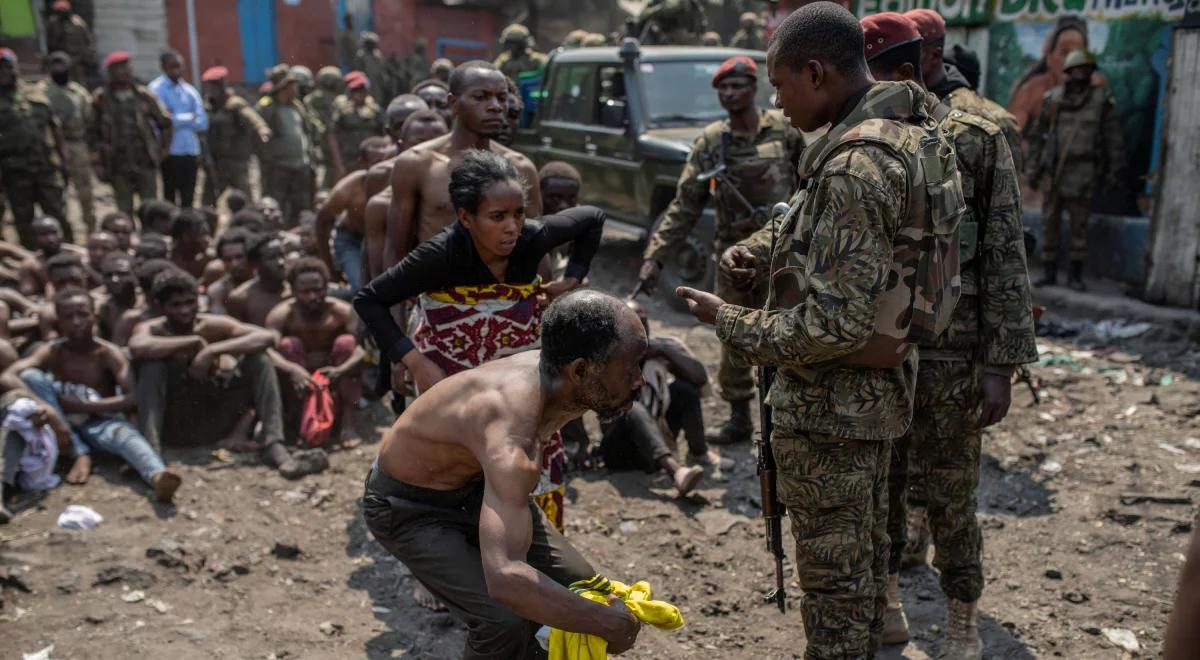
[{"xmin": 772, "ymin": 99, "xmax": 966, "ymax": 368}]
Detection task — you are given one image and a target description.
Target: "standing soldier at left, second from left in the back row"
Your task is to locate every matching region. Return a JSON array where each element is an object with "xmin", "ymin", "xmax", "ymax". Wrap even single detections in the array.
[{"xmin": 42, "ymin": 50, "xmax": 96, "ymax": 234}]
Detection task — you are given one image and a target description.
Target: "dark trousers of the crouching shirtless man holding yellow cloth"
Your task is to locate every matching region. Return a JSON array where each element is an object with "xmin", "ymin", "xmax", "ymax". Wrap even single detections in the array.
[{"xmin": 362, "ymin": 468, "xmax": 595, "ymax": 660}]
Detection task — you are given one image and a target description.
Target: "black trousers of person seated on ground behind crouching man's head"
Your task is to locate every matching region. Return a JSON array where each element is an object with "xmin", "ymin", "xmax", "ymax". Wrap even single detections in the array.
[{"xmin": 600, "ymin": 379, "xmax": 708, "ymax": 472}]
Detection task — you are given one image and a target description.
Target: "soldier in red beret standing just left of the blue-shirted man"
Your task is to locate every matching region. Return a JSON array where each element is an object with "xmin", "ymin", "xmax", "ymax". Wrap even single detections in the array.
[{"xmin": 92, "ymin": 50, "xmax": 172, "ymax": 214}]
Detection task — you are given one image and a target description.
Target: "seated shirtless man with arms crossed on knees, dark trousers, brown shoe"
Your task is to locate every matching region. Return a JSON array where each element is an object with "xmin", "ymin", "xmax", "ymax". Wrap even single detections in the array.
[{"xmin": 130, "ymin": 268, "xmax": 304, "ymax": 472}]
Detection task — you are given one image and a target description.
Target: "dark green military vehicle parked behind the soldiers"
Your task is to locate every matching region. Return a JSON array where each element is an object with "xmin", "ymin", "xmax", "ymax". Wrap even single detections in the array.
[{"xmin": 512, "ymin": 38, "xmax": 774, "ymax": 300}]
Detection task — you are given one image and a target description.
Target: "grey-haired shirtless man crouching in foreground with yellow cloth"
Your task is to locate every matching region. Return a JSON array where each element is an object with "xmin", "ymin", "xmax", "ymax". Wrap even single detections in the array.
[{"xmin": 364, "ymin": 290, "xmax": 647, "ymax": 659}]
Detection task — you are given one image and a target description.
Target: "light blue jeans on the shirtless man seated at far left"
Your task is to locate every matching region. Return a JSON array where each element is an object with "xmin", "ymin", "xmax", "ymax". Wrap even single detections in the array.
[{"xmin": 20, "ymin": 368, "xmax": 166, "ymax": 484}]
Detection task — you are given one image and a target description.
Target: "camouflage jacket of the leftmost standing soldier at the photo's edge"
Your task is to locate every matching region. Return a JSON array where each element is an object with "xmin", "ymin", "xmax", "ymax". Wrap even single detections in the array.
[{"xmin": 0, "ymin": 79, "xmax": 59, "ymax": 174}]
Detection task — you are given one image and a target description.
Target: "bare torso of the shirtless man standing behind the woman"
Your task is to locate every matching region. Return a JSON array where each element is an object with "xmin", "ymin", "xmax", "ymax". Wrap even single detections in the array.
[{"xmin": 383, "ymin": 132, "xmax": 541, "ymax": 268}]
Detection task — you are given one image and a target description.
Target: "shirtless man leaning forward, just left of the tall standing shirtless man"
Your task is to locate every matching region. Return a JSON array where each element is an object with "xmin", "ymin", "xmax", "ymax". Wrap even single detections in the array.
[{"xmin": 316, "ymin": 136, "xmax": 395, "ymax": 292}]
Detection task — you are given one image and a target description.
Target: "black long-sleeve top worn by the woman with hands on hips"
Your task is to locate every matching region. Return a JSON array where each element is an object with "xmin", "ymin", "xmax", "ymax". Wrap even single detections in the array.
[{"xmin": 354, "ymin": 206, "xmax": 605, "ymax": 364}]
